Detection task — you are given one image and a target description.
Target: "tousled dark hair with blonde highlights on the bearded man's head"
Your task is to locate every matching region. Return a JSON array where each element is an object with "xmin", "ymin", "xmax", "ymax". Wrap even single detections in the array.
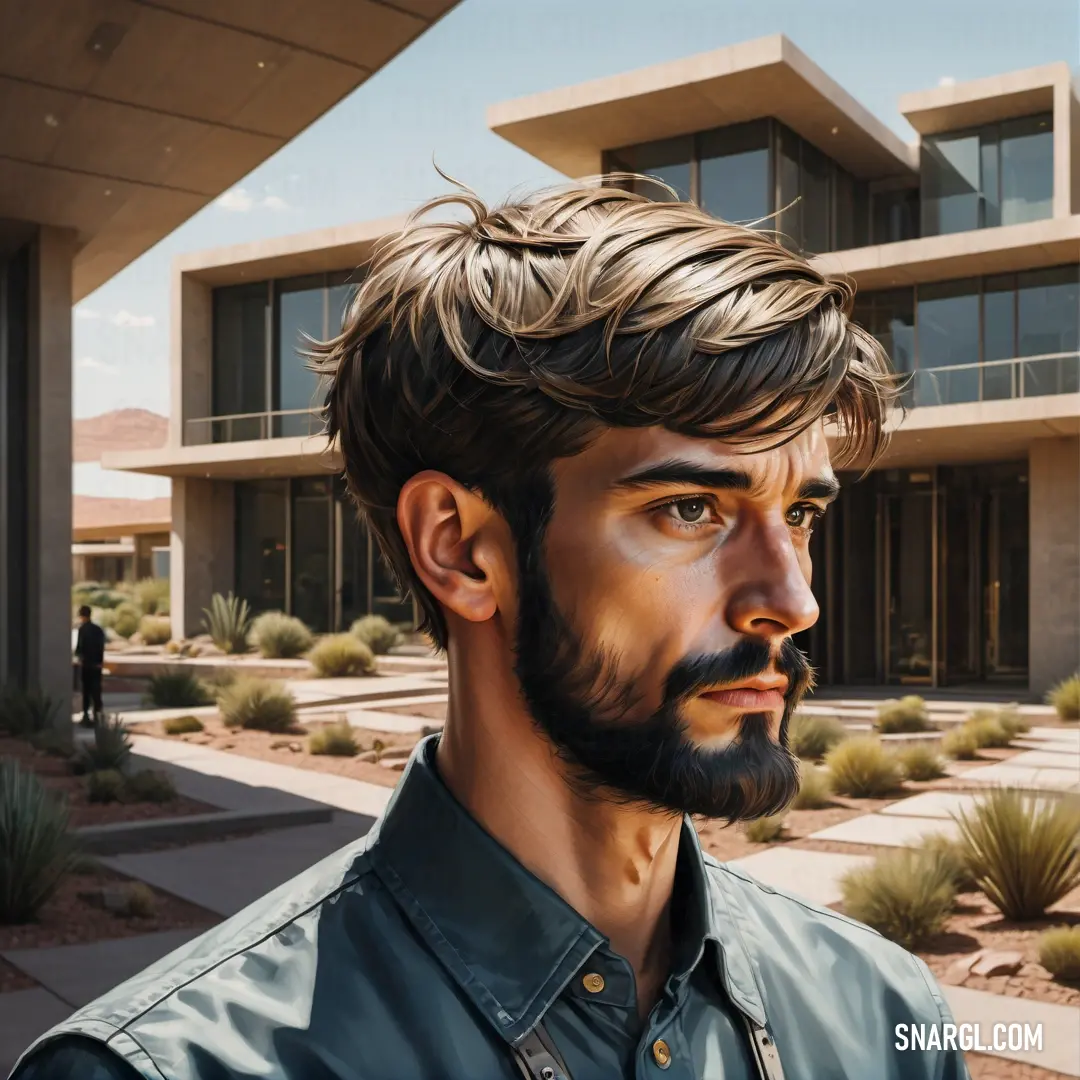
[{"xmin": 312, "ymin": 183, "xmax": 895, "ymax": 646}]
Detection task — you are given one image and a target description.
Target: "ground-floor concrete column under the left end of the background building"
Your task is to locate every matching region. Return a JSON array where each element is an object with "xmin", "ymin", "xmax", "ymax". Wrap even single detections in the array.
[{"xmin": 168, "ymin": 476, "xmax": 235, "ymax": 637}]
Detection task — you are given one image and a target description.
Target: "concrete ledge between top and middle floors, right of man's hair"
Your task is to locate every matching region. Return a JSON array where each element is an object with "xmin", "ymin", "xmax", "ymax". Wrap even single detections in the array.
[{"xmin": 812, "ymin": 214, "xmax": 1080, "ymax": 289}]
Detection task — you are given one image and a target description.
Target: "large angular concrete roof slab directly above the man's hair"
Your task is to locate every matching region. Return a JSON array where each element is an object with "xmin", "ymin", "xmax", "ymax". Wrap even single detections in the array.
[{"xmin": 487, "ymin": 35, "xmax": 918, "ymax": 179}]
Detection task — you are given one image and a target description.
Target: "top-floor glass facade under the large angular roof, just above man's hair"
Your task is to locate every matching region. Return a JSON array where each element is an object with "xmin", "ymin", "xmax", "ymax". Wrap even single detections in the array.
[{"xmin": 604, "ymin": 120, "xmax": 869, "ymax": 254}]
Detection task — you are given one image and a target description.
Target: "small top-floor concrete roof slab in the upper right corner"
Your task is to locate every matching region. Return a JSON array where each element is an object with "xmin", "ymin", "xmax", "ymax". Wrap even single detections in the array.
[{"xmin": 900, "ymin": 63, "xmax": 1071, "ymax": 135}]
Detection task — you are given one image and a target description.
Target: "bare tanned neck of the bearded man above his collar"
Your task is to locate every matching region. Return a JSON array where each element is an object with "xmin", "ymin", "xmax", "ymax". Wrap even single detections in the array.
[{"xmin": 436, "ymin": 648, "xmax": 681, "ymax": 1016}]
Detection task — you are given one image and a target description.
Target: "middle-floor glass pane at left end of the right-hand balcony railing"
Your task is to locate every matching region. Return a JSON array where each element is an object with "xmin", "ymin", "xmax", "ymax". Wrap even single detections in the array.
[{"xmin": 915, "ymin": 279, "xmax": 980, "ymax": 405}]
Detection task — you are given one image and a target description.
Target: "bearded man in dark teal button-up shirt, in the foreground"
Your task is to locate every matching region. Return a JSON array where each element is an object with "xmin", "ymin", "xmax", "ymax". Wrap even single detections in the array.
[{"xmin": 10, "ymin": 187, "xmax": 967, "ymax": 1080}]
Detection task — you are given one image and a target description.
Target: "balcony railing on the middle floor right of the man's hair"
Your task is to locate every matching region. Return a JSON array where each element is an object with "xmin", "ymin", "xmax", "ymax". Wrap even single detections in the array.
[{"xmin": 904, "ymin": 352, "xmax": 1080, "ymax": 406}]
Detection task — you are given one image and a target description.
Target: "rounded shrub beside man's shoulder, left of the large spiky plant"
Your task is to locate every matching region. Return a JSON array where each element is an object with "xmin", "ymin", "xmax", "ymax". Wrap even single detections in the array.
[{"xmin": 840, "ymin": 850, "xmax": 956, "ymax": 949}]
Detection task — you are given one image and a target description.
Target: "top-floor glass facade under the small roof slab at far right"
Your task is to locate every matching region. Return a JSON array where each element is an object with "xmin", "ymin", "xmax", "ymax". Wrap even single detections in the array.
[{"xmin": 920, "ymin": 112, "xmax": 1054, "ymax": 237}]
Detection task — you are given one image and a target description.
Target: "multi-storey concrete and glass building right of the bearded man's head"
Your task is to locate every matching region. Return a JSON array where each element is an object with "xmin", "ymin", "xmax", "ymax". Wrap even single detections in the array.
[{"xmin": 488, "ymin": 36, "xmax": 1080, "ymax": 694}]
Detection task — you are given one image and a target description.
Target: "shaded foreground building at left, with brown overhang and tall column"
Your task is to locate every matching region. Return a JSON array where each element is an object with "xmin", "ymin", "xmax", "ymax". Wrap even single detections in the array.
[{"xmin": 0, "ymin": 0, "xmax": 454, "ymax": 697}]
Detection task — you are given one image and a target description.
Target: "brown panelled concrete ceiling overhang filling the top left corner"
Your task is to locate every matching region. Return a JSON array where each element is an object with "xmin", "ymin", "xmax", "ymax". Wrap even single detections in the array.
[{"xmin": 0, "ymin": 0, "xmax": 456, "ymax": 300}]
